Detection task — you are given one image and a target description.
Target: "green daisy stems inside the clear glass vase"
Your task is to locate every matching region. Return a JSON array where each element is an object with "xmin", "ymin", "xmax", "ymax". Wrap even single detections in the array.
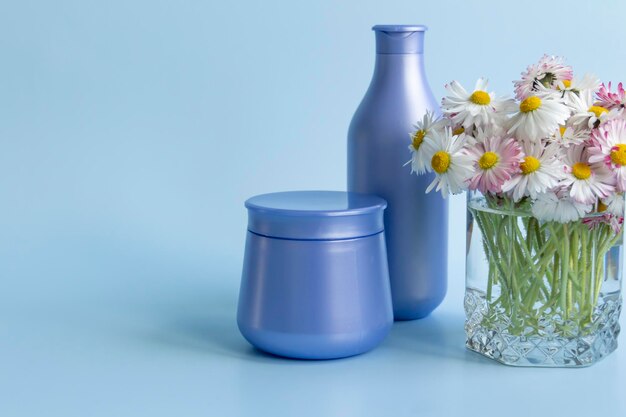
[{"xmin": 471, "ymin": 198, "xmax": 621, "ymax": 336}]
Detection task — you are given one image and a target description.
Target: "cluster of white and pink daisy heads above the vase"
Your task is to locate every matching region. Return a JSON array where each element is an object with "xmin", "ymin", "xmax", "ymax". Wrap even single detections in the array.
[{"xmin": 409, "ymin": 55, "xmax": 626, "ymax": 228}]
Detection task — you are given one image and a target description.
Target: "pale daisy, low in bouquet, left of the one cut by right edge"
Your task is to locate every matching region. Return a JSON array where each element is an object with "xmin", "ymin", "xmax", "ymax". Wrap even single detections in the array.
[{"xmin": 561, "ymin": 145, "xmax": 615, "ymax": 204}]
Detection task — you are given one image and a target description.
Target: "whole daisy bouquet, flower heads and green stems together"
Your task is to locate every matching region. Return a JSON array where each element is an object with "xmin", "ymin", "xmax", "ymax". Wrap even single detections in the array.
[{"xmin": 409, "ymin": 55, "xmax": 626, "ymax": 333}]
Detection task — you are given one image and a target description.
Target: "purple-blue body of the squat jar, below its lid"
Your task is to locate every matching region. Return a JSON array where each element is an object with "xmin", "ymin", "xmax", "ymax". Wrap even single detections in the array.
[{"xmin": 237, "ymin": 232, "xmax": 393, "ymax": 359}]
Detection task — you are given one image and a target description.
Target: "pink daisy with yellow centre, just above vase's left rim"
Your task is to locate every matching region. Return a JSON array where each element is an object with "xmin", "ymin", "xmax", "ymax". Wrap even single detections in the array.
[{"xmin": 468, "ymin": 136, "xmax": 522, "ymax": 194}]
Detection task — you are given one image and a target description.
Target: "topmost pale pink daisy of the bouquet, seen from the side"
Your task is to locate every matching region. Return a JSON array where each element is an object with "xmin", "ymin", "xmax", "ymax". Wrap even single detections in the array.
[{"xmin": 513, "ymin": 55, "xmax": 573, "ymax": 100}]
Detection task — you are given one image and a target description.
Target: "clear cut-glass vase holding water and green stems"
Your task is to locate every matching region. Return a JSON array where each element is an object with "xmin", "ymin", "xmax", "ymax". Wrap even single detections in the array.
[{"xmin": 465, "ymin": 194, "xmax": 623, "ymax": 367}]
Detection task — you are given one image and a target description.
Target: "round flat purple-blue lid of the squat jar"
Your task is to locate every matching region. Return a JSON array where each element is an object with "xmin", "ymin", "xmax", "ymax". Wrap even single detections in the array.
[{"xmin": 246, "ymin": 191, "xmax": 387, "ymax": 240}]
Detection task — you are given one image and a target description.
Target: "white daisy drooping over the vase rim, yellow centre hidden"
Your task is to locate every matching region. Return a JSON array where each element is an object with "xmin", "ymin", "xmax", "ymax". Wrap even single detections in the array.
[{"xmin": 531, "ymin": 191, "xmax": 593, "ymax": 223}]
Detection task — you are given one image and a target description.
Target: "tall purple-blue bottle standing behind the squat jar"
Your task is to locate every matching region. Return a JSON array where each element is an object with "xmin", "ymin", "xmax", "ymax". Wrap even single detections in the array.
[{"xmin": 348, "ymin": 25, "xmax": 448, "ymax": 320}]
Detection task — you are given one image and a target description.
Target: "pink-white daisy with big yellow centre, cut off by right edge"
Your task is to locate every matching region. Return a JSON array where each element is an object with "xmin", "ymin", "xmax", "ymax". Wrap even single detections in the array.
[{"xmin": 588, "ymin": 119, "xmax": 626, "ymax": 192}]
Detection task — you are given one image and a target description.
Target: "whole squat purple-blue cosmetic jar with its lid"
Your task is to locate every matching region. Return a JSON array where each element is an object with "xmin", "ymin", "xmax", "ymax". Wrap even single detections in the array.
[{"xmin": 237, "ymin": 191, "xmax": 393, "ymax": 359}]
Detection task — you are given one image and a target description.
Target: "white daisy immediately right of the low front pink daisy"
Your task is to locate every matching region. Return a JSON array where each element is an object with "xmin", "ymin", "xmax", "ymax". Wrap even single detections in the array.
[{"xmin": 502, "ymin": 142, "xmax": 564, "ymax": 201}]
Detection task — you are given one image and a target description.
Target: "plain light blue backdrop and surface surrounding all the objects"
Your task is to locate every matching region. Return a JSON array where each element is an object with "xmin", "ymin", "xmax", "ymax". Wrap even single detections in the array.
[{"xmin": 0, "ymin": 0, "xmax": 626, "ymax": 417}]
